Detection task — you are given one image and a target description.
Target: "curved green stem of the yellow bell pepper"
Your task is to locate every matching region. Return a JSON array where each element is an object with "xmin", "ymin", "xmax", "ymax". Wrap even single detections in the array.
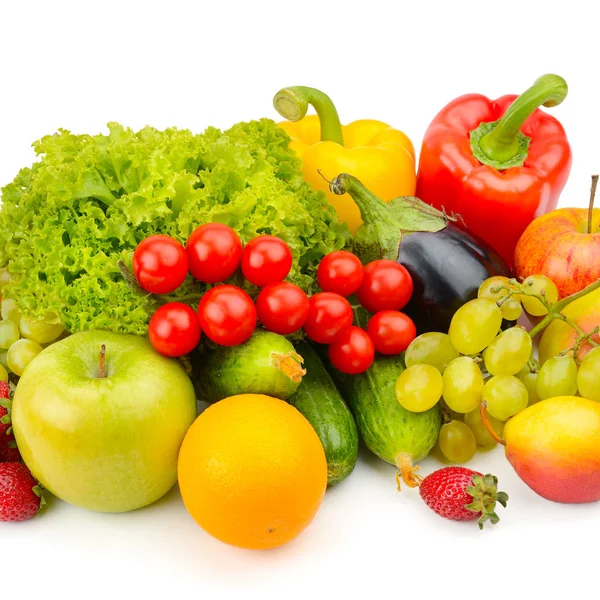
[{"xmin": 273, "ymin": 85, "xmax": 344, "ymax": 146}]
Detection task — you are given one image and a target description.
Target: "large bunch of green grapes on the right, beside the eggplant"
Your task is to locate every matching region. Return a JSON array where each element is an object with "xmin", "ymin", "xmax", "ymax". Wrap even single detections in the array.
[{"xmin": 396, "ymin": 275, "xmax": 600, "ymax": 463}]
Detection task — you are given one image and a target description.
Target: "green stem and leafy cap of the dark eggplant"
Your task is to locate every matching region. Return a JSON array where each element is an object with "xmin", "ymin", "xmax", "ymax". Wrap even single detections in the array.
[{"xmin": 329, "ymin": 173, "xmax": 451, "ymax": 262}]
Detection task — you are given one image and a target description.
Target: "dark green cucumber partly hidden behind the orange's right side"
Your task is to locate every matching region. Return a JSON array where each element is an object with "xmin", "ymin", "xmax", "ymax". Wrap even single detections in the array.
[{"xmin": 288, "ymin": 342, "xmax": 358, "ymax": 485}]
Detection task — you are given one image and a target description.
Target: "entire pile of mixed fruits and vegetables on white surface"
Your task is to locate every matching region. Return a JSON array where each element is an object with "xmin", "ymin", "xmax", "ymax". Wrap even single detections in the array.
[{"xmin": 0, "ymin": 75, "xmax": 600, "ymax": 548}]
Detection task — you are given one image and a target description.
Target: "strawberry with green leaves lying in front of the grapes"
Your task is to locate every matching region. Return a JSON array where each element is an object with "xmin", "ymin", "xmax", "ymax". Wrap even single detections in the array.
[{"xmin": 419, "ymin": 467, "xmax": 508, "ymax": 529}]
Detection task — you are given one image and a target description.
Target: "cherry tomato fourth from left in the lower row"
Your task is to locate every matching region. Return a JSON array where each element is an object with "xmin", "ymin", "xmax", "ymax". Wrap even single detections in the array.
[{"xmin": 304, "ymin": 292, "xmax": 352, "ymax": 344}]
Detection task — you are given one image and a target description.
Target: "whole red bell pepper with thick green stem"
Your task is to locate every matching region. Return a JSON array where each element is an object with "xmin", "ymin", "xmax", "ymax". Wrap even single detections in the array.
[{"xmin": 417, "ymin": 75, "xmax": 571, "ymax": 267}]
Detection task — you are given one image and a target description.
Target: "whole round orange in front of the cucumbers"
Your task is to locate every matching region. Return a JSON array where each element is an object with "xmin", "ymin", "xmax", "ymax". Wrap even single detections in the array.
[{"xmin": 178, "ymin": 394, "xmax": 327, "ymax": 549}]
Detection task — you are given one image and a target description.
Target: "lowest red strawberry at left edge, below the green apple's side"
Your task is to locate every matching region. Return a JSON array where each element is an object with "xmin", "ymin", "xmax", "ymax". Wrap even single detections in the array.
[{"xmin": 0, "ymin": 462, "xmax": 42, "ymax": 522}]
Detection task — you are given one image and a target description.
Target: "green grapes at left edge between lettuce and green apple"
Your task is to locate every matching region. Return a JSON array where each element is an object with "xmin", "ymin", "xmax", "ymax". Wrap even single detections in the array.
[{"xmin": 0, "ymin": 270, "xmax": 64, "ymax": 381}]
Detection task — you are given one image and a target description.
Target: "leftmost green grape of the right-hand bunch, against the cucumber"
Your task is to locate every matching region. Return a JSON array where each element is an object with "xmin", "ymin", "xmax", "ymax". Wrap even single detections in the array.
[{"xmin": 396, "ymin": 365, "xmax": 443, "ymax": 412}]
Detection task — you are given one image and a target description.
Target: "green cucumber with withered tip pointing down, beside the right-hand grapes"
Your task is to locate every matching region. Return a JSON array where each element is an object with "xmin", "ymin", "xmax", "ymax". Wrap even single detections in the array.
[{"xmin": 325, "ymin": 356, "xmax": 442, "ymax": 487}]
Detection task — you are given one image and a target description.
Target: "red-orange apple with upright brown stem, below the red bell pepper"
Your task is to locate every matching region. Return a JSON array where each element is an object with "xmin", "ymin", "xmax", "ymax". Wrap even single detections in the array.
[{"xmin": 515, "ymin": 176, "xmax": 600, "ymax": 298}]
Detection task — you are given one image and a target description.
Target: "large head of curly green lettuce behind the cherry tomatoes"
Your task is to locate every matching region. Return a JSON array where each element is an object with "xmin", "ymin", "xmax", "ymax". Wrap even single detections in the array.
[{"xmin": 0, "ymin": 119, "xmax": 348, "ymax": 335}]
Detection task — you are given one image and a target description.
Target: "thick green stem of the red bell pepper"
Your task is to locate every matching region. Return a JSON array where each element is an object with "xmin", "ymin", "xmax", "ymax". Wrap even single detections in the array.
[{"xmin": 479, "ymin": 74, "xmax": 568, "ymax": 163}]
